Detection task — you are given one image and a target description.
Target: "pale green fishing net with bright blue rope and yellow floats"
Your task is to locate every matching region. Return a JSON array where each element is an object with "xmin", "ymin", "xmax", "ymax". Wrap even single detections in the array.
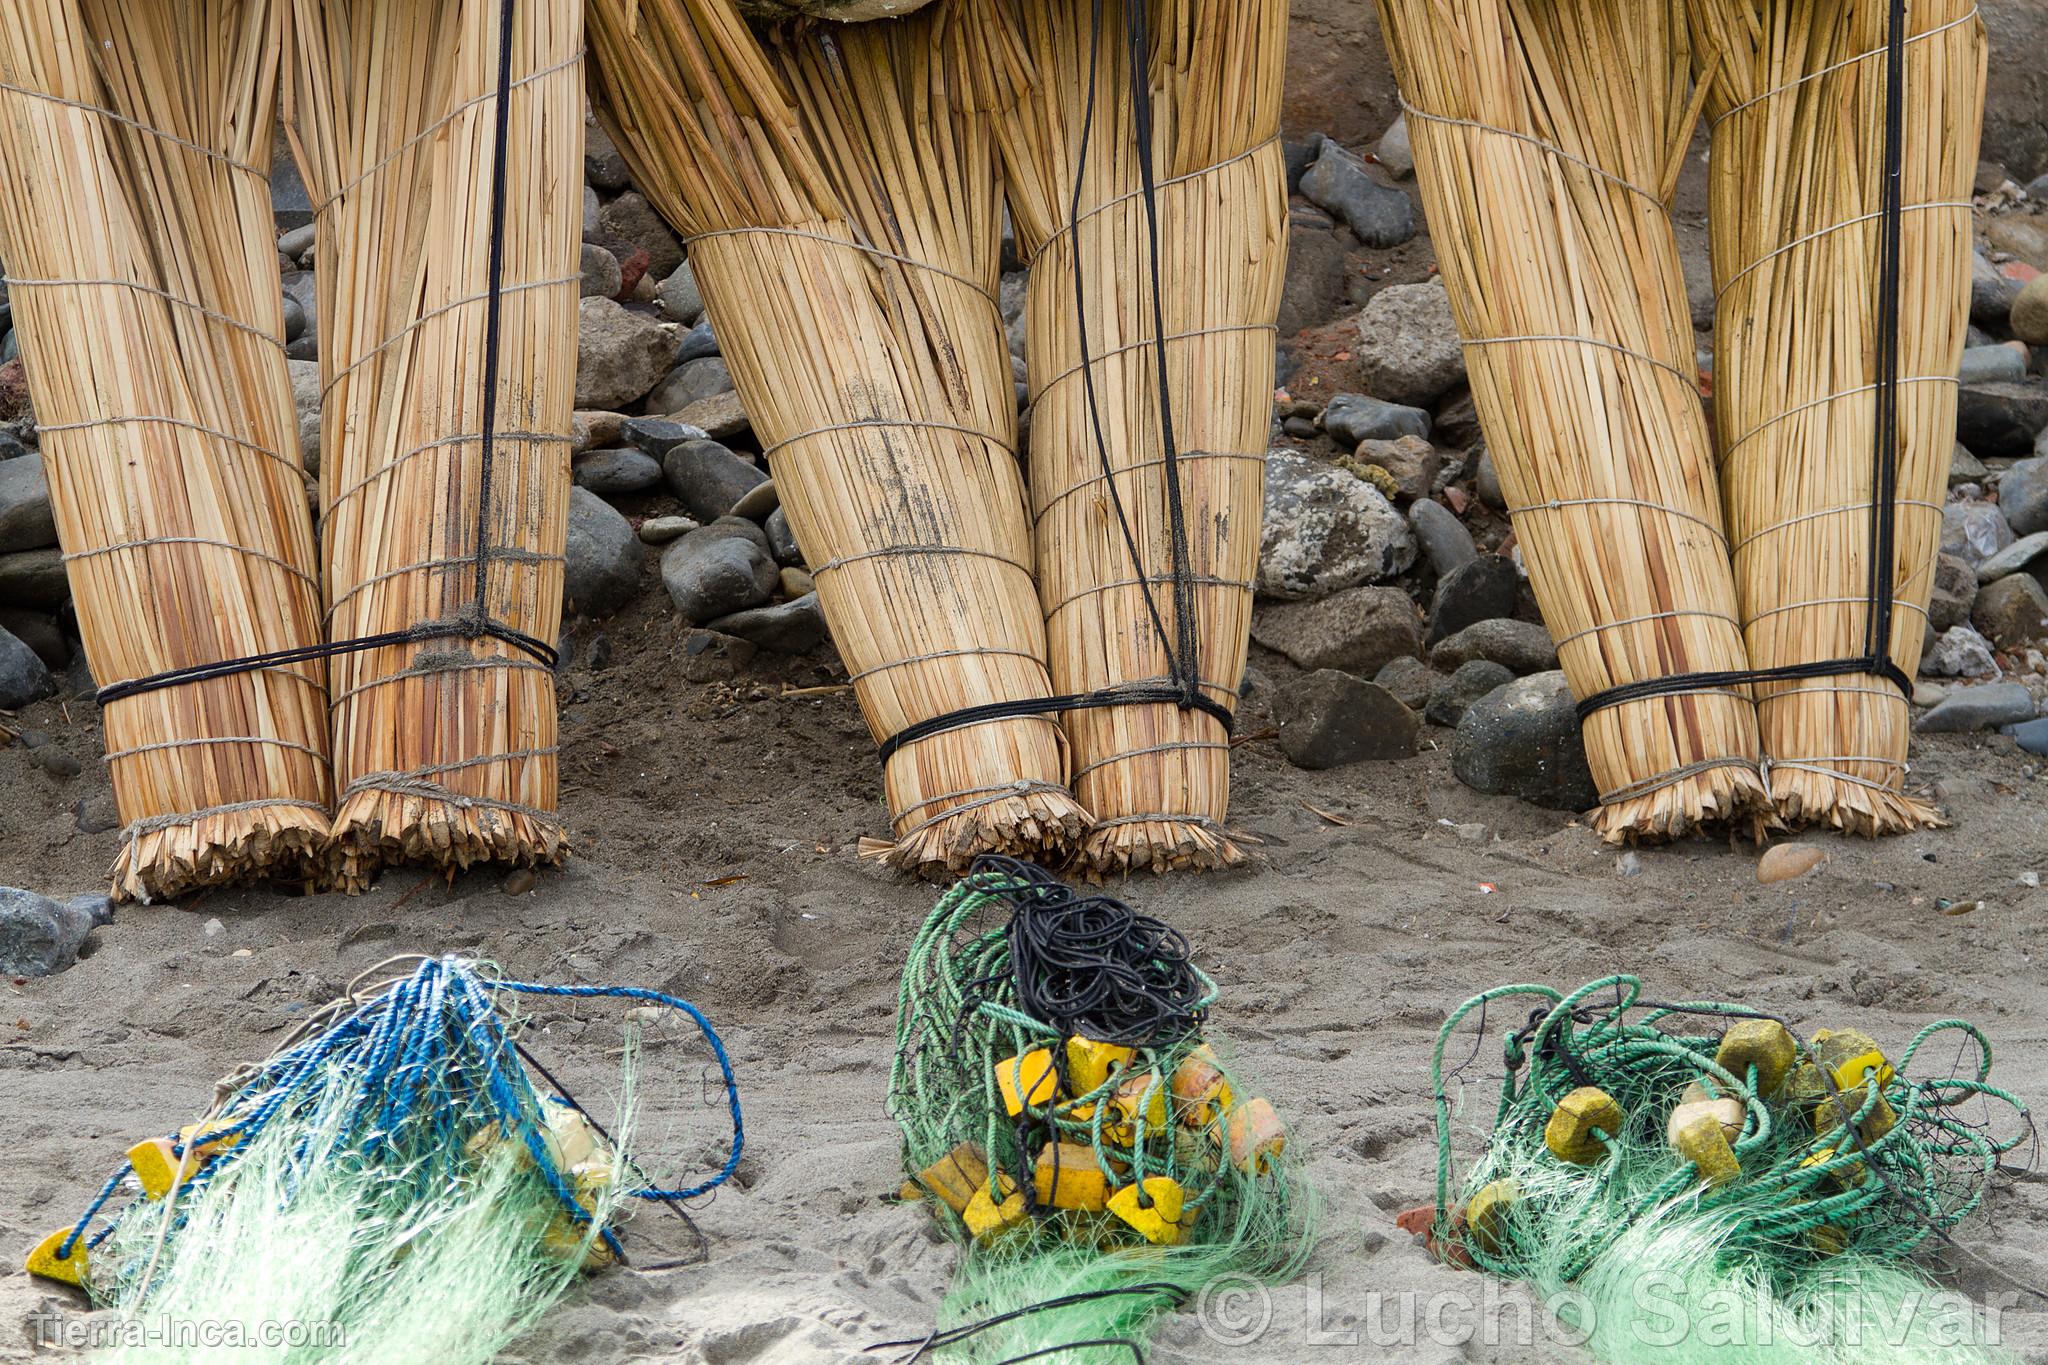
[{"xmin": 31, "ymin": 958, "xmax": 741, "ymax": 1365}]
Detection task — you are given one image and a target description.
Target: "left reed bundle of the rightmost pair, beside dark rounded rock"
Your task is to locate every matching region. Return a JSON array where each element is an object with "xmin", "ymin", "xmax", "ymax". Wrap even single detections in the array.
[{"xmin": 1380, "ymin": 0, "xmax": 1763, "ymax": 841}]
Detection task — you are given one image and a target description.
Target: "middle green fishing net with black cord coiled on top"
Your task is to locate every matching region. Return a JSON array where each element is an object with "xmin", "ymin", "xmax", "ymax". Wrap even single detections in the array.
[{"xmin": 887, "ymin": 857, "xmax": 1317, "ymax": 1365}]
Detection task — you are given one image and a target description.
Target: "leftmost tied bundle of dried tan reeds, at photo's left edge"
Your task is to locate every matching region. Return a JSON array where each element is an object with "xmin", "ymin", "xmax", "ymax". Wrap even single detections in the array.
[{"xmin": 0, "ymin": 0, "xmax": 330, "ymax": 898}]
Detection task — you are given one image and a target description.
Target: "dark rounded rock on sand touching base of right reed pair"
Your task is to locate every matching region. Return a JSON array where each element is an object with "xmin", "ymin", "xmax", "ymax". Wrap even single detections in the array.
[{"xmin": 1450, "ymin": 673, "xmax": 1599, "ymax": 810}]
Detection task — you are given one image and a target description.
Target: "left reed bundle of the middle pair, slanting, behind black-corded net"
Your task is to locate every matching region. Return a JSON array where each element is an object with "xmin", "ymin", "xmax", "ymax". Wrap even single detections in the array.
[{"xmin": 590, "ymin": 0, "xmax": 1087, "ymax": 874}]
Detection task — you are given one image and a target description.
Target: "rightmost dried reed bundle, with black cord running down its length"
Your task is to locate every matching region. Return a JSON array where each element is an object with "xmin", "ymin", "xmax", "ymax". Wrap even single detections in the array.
[{"xmin": 1690, "ymin": 0, "xmax": 1985, "ymax": 835}]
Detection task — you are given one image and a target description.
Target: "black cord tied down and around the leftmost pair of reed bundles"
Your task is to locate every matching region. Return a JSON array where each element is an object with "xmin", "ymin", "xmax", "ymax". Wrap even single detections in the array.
[{"xmin": 94, "ymin": 0, "xmax": 559, "ymax": 706}]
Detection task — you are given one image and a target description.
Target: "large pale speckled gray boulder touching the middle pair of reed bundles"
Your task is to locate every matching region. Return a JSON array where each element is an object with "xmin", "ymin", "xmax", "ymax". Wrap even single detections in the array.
[{"xmin": 1260, "ymin": 450, "xmax": 1417, "ymax": 602}]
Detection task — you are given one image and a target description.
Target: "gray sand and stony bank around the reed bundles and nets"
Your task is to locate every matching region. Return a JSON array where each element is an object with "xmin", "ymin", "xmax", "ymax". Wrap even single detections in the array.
[{"xmin": 0, "ymin": 10, "xmax": 2048, "ymax": 1363}]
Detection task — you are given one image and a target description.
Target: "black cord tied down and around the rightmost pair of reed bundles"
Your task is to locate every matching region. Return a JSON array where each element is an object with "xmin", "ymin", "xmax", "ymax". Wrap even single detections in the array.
[{"xmin": 1579, "ymin": 0, "xmax": 1913, "ymax": 720}]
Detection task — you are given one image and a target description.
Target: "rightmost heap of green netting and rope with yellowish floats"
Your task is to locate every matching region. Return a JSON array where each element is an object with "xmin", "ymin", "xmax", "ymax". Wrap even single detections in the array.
[{"xmin": 1432, "ymin": 976, "xmax": 2034, "ymax": 1363}]
